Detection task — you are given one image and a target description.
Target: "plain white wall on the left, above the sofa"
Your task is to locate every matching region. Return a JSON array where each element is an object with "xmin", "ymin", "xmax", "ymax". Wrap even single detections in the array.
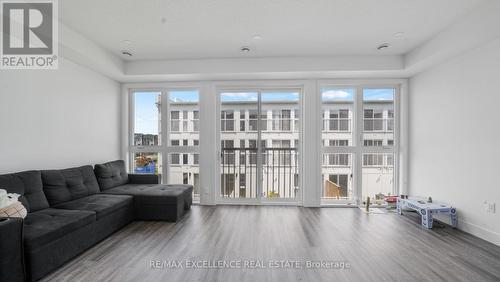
[{"xmin": 0, "ymin": 58, "xmax": 121, "ymax": 173}]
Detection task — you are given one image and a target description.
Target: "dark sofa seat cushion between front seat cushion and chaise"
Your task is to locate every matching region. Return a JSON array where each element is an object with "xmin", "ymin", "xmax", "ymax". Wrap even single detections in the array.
[{"xmin": 54, "ymin": 194, "xmax": 133, "ymax": 220}]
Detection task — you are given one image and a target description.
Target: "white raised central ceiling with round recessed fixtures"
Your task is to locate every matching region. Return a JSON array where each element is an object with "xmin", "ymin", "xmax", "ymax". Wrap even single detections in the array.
[{"xmin": 59, "ymin": 0, "xmax": 484, "ymax": 60}]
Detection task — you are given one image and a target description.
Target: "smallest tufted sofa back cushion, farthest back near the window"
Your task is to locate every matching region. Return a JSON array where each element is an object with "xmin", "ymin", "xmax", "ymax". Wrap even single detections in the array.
[{"xmin": 94, "ymin": 160, "xmax": 128, "ymax": 191}]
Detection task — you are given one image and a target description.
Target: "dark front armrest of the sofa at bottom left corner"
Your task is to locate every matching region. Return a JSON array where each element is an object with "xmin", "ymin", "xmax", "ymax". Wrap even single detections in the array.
[{"xmin": 0, "ymin": 217, "xmax": 25, "ymax": 281}]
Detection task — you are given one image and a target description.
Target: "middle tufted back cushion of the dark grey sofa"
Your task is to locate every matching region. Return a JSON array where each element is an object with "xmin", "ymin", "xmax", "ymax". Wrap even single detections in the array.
[{"xmin": 42, "ymin": 165, "xmax": 100, "ymax": 206}]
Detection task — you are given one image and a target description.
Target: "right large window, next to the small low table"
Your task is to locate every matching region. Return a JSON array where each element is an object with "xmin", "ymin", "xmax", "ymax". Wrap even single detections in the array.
[{"xmin": 321, "ymin": 85, "xmax": 398, "ymax": 204}]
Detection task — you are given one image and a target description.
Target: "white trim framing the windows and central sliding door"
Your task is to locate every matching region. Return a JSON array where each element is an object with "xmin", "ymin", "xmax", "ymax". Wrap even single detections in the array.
[{"xmin": 122, "ymin": 79, "xmax": 408, "ymax": 207}]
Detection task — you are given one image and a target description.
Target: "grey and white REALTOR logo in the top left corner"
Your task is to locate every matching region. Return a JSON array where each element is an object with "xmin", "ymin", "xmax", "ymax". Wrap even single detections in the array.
[{"xmin": 0, "ymin": 0, "xmax": 58, "ymax": 69}]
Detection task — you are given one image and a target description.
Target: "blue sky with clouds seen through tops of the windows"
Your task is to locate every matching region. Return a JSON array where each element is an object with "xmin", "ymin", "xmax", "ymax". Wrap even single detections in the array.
[{"xmin": 134, "ymin": 87, "xmax": 394, "ymax": 134}]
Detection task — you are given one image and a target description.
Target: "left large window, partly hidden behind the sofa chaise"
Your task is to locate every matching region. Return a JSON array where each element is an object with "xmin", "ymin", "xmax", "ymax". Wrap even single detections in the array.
[{"xmin": 130, "ymin": 89, "xmax": 200, "ymax": 201}]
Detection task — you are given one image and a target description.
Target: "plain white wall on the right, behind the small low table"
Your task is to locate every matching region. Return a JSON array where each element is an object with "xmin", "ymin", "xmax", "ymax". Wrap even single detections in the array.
[{"xmin": 409, "ymin": 39, "xmax": 500, "ymax": 245}]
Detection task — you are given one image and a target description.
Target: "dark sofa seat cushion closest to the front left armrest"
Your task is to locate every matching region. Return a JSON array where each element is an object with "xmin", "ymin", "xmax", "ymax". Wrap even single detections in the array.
[{"xmin": 24, "ymin": 208, "xmax": 96, "ymax": 249}]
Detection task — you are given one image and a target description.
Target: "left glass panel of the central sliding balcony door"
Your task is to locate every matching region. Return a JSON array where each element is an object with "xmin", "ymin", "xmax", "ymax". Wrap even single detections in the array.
[{"xmin": 220, "ymin": 92, "xmax": 258, "ymax": 198}]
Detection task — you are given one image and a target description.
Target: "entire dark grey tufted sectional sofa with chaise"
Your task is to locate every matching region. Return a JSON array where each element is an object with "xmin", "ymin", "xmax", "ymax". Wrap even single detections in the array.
[{"xmin": 0, "ymin": 160, "xmax": 193, "ymax": 281}]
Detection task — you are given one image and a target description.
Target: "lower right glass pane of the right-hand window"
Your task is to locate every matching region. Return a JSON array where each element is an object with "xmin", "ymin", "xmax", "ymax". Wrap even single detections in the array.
[{"xmin": 361, "ymin": 154, "xmax": 394, "ymax": 204}]
